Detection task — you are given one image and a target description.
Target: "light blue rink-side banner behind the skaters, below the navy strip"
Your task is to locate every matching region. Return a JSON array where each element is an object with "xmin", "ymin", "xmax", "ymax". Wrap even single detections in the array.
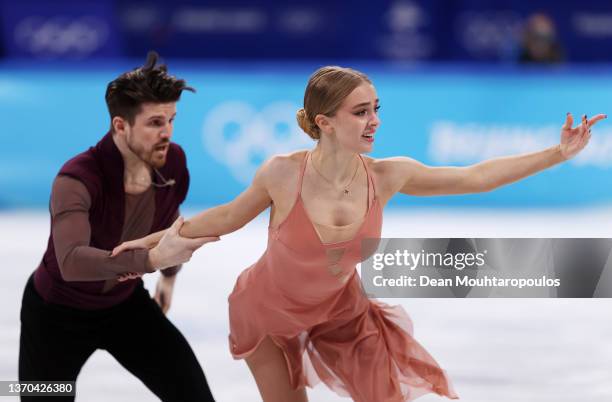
[{"xmin": 0, "ymin": 62, "xmax": 612, "ymax": 207}]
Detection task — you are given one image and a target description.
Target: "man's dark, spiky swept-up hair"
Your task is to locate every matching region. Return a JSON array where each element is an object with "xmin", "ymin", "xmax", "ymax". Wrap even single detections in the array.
[{"xmin": 105, "ymin": 51, "xmax": 195, "ymax": 129}]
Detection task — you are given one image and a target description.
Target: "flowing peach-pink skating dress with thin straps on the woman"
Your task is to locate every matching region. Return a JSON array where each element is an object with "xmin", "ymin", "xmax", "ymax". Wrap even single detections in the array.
[{"xmin": 229, "ymin": 153, "xmax": 457, "ymax": 402}]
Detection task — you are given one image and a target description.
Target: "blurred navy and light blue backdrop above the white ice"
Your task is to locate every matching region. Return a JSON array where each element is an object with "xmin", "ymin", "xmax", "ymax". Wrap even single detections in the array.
[{"xmin": 0, "ymin": 0, "xmax": 612, "ymax": 208}]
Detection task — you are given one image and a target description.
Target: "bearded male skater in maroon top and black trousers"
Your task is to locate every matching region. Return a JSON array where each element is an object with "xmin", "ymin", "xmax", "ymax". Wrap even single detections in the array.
[{"xmin": 19, "ymin": 52, "xmax": 215, "ymax": 402}]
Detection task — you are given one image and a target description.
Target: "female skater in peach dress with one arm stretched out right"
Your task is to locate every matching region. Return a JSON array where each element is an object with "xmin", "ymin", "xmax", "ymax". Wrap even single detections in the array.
[{"xmin": 114, "ymin": 67, "xmax": 605, "ymax": 402}]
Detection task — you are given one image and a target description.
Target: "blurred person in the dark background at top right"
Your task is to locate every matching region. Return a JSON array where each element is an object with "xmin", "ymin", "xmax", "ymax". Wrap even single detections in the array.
[{"xmin": 519, "ymin": 13, "xmax": 565, "ymax": 63}]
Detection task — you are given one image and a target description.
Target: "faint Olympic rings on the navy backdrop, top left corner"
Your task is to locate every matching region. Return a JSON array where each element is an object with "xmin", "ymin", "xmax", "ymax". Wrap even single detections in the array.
[{"xmin": 14, "ymin": 16, "xmax": 110, "ymax": 57}]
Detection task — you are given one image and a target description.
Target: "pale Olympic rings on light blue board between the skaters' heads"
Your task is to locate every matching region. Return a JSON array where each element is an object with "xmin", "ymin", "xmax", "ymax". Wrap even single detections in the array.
[{"xmin": 202, "ymin": 101, "xmax": 312, "ymax": 184}]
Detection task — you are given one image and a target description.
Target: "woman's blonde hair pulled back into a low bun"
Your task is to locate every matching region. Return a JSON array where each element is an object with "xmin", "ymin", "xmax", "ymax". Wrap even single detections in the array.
[{"xmin": 297, "ymin": 66, "xmax": 372, "ymax": 140}]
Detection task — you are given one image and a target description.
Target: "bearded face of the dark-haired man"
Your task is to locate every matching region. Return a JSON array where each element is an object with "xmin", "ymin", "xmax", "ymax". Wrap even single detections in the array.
[{"xmin": 125, "ymin": 102, "xmax": 176, "ymax": 168}]
